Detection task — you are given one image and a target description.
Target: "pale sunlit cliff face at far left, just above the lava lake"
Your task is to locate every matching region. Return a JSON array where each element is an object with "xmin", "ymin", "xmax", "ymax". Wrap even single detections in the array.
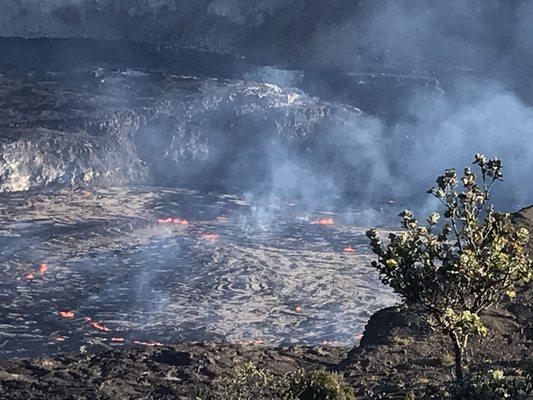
[{"xmin": 0, "ymin": 128, "xmax": 147, "ymax": 192}]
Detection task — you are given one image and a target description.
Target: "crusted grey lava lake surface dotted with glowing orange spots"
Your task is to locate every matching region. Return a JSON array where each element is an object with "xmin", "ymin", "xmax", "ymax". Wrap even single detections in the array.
[{"xmin": 0, "ymin": 187, "xmax": 395, "ymax": 358}]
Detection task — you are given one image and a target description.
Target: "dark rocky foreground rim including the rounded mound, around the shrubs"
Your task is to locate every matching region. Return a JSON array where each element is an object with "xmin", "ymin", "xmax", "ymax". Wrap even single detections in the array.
[{"xmin": 0, "ymin": 208, "xmax": 533, "ymax": 400}]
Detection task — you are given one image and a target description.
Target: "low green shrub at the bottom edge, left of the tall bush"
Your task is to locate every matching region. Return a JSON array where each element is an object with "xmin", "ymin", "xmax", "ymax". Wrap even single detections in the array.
[{"xmin": 206, "ymin": 363, "xmax": 355, "ymax": 400}]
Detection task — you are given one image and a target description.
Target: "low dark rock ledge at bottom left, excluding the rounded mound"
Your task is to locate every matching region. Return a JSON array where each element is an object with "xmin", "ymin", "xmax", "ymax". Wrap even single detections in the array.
[{"xmin": 0, "ymin": 344, "xmax": 344, "ymax": 400}]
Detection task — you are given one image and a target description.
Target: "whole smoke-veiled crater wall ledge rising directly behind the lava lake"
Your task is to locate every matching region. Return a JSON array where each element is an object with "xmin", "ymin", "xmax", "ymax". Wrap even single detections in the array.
[{"xmin": 0, "ymin": 69, "xmax": 380, "ymax": 199}]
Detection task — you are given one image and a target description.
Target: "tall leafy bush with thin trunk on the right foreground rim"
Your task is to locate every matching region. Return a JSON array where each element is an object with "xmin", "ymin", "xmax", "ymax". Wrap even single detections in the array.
[{"xmin": 367, "ymin": 154, "xmax": 533, "ymax": 380}]
